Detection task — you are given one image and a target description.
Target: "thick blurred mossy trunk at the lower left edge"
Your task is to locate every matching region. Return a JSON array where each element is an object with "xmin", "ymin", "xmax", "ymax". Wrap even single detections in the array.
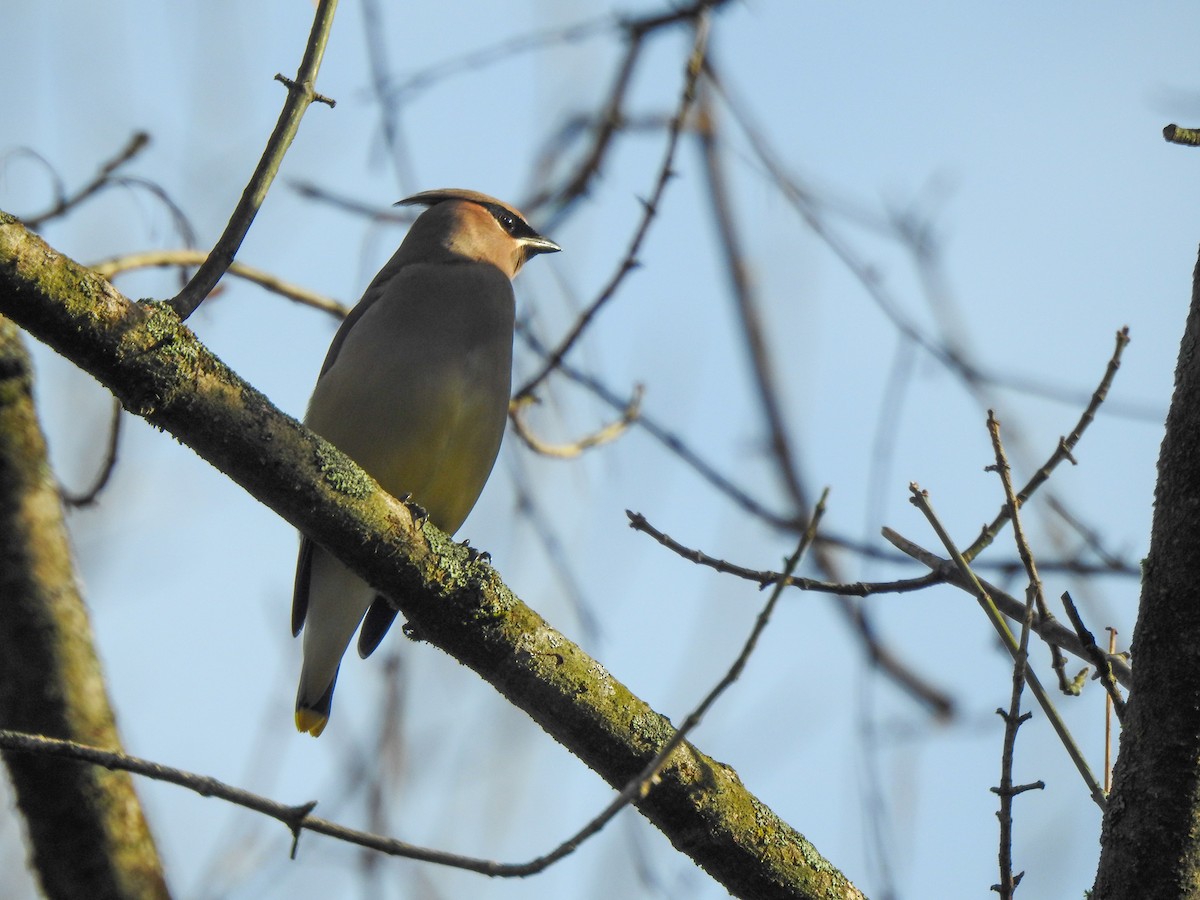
[{"xmin": 0, "ymin": 321, "xmax": 168, "ymax": 900}]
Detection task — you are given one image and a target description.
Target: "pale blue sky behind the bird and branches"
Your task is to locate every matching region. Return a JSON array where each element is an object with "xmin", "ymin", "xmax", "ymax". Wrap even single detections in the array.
[{"xmin": 0, "ymin": 0, "xmax": 1200, "ymax": 900}]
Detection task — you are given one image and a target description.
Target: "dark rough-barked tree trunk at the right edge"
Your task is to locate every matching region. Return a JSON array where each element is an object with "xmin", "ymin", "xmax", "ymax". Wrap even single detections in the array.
[{"xmin": 1093, "ymin": 248, "xmax": 1200, "ymax": 900}]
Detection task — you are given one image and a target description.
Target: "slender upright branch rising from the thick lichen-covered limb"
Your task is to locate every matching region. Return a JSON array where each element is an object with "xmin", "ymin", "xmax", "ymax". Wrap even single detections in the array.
[{"xmin": 170, "ymin": 0, "xmax": 337, "ymax": 319}]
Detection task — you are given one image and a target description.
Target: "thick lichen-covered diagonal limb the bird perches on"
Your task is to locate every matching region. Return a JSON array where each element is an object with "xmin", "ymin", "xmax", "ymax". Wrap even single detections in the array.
[{"xmin": 0, "ymin": 214, "xmax": 857, "ymax": 898}]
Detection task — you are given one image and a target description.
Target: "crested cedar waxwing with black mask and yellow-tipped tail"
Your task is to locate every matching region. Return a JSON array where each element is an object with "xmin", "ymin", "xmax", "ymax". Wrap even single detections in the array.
[{"xmin": 292, "ymin": 190, "xmax": 560, "ymax": 737}]
